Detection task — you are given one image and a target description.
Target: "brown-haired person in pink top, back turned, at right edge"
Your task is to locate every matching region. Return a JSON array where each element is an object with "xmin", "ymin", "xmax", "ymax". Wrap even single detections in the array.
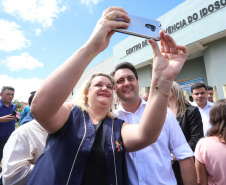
[{"xmin": 195, "ymin": 99, "xmax": 226, "ymax": 185}]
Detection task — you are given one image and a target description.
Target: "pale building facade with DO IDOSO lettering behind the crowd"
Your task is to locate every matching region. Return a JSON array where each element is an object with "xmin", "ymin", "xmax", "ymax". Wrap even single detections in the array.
[{"xmin": 70, "ymin": 0, "xmax": 226, "ymax": 101}]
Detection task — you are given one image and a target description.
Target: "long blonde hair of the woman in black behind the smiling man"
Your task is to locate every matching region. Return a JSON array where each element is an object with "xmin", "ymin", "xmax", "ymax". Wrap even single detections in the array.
[{"xmin": 171, "ymin": 82, "xmax": 191, "ymax": 117}]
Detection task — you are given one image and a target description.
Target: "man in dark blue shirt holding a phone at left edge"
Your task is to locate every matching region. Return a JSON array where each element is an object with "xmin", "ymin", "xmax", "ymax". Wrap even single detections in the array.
[{"xmin": 0, "ymin": 86, "xmax": 17, "ymax": 171}]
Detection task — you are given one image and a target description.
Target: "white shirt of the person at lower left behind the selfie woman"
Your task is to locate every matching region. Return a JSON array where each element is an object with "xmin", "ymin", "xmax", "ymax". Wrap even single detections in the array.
[{"xmin": 2, "ymin": 120, "xmax": 47, "ymax": 185}]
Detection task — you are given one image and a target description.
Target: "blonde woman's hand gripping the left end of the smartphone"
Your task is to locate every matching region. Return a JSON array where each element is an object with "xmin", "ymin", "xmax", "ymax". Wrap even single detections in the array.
[{"xmin": 86, "ymin": 7, "xmax": 130, "ymax": 54}]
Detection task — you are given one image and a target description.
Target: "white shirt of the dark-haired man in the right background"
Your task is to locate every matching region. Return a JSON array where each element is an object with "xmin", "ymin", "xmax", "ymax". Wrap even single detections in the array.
[{"xmin": 190, "ymin": 101, "xmax": 214, "ymax": 136}]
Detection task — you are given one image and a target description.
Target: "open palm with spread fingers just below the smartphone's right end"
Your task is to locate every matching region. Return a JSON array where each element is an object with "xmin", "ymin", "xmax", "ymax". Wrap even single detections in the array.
[{"xmin": 148, "ymin": 30, "xmax": 188, "ymax": 81}]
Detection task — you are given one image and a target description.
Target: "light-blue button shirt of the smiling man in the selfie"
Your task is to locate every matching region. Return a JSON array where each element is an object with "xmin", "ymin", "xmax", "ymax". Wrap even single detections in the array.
[{"xmin": 117, "ymin": 99, "xmax": 193, "ymax": 185}]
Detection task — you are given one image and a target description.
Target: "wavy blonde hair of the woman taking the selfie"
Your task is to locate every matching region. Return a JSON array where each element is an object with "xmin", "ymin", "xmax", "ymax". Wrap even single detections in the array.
[{"xmin": 71, "ymin": 73, "xmax": 115, "ymax": 118}]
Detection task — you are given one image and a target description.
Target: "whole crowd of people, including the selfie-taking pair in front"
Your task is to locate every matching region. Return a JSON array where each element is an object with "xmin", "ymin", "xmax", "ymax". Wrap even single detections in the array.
[{"xmin": 0, "ymin": 7, "xmax": 226, "ymax": 185}]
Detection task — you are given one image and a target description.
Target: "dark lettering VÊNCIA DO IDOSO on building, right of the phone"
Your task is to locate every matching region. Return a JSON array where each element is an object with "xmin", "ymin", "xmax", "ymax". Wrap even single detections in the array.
[{"xmin": 166, "ymin": 0, "xmax": 226, "ymax": 34}]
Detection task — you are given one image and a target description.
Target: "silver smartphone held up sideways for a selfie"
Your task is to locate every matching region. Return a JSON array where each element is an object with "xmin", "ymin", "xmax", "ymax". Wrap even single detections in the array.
[{"xmin": 113, "ymin": 14, "xmax": 161, "ymax": 41}]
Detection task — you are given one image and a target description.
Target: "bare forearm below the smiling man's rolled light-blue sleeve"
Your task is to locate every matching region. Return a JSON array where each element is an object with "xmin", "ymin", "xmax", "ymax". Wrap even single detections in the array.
[{"xmin": 179, "ymin": 157, "xmax": 197, "ymax": 185}]
